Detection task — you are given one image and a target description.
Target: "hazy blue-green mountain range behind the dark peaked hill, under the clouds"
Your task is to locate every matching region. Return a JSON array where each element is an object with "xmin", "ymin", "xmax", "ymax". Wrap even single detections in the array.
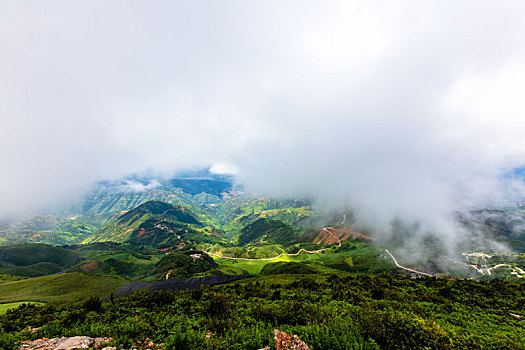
[{"xmin": 0, "ymin": 169, "xmax": 312, "ymax": 246}]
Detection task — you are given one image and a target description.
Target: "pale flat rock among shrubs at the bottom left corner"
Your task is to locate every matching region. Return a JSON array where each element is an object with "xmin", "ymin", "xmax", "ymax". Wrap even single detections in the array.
[{"xmin": 20, "ymin": 337, "xmax": 113, "ymax": 350}]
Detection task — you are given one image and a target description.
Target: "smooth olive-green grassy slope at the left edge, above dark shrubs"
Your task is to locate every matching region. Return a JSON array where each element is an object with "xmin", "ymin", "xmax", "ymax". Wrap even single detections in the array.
[{"xmin": 0, "ymin": 273, "xmax": 129, "ymax": 303}]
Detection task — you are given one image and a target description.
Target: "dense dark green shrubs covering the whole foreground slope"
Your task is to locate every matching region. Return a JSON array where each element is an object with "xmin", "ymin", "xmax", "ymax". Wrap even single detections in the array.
[{"xmin": 0, "ymin": 274, "xmax": 525, "ymax": 350}]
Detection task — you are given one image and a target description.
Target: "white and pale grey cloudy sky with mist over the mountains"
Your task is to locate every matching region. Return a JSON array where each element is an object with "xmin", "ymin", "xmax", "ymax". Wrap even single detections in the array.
[{"xmin": 0, "ymin": 0, "xmax": 525, "ymax": 241}]
